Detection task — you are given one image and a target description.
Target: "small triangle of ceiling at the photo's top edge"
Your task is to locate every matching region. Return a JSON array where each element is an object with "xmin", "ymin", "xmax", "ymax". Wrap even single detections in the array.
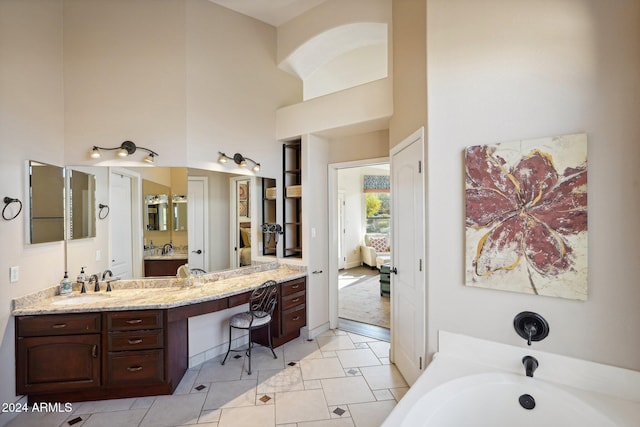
[{"xmin": 209, "ymin": 0, "xmax": 326, "ymax": 27}]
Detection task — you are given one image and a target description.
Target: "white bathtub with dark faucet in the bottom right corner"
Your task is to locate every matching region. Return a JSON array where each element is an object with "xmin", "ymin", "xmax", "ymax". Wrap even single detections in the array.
[{"xmin": 383, "ymin": 332, "xmax": 640, "ymax": 427}]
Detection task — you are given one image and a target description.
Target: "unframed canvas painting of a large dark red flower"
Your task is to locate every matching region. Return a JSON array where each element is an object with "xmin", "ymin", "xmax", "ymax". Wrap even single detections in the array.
[{"xmin": 465, "ymin": 134, "xmax": 588, "ymax": 300}]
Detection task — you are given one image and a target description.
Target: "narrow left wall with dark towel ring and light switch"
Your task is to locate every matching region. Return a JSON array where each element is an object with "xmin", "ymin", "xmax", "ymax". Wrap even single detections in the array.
[{"xmin": 0, "ymin": 0, "xmax": 64, "ymax": 416}]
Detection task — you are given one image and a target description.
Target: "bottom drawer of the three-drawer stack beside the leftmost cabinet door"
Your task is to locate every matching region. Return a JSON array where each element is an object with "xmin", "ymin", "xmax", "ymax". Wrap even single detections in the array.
[{"xmin": 107, "ymin": 350, "xmax": 164, "ymax": 385}]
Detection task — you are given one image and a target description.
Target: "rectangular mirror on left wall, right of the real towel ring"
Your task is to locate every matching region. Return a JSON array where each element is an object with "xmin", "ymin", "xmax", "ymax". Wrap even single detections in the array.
[{"xmin": 28, "ymin": 160, "xmax": 65, "ymax": 244}]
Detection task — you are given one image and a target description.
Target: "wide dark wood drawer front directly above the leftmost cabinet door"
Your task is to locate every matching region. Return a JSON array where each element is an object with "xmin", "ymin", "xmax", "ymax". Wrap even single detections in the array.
[{"xmin": 16, "ymin": 313, "xmax": 100, "ymax": 337}]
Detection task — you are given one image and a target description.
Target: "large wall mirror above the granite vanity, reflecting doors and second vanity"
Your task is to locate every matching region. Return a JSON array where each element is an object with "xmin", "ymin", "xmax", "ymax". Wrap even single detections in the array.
[{"xmin": 67, "ymin": 167, "xmax": 275, "ymax": 279}]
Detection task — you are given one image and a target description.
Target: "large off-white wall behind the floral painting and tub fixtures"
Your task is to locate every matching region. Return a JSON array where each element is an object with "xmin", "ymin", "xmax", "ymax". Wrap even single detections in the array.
[{"xmin": 427, "ymin": 0, "xmax": 640, "ymax": 370}]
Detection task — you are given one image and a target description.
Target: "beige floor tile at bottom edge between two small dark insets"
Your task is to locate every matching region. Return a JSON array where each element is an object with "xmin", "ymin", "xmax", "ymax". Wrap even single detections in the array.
[{"xmin": 275, "ymin": 390, "xmax": 330, "ymax": 424}]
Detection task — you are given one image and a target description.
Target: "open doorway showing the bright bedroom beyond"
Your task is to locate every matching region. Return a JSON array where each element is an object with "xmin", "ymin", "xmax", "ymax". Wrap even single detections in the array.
[{"xmin": 329, "ymin": 158, "xmax": 391, "ymax": 341}]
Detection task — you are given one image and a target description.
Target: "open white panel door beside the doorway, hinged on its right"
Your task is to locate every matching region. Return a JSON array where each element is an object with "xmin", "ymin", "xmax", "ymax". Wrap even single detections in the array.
[{"xmin": 391, "ymin": 131, "xmax": 426, "ymax": 384}]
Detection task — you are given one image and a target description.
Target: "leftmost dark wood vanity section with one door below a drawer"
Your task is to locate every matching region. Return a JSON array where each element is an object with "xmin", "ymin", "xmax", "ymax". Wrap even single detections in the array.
[{"xmin": 16, "ymin": 313, "xmax": 101, "ymax": 394}]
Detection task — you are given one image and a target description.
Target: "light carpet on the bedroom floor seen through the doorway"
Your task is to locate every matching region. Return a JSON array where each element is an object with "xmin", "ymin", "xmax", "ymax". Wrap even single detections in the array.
[{"xmin": 338, "ymin": 275, "xmax": 390, "ymax": 328}]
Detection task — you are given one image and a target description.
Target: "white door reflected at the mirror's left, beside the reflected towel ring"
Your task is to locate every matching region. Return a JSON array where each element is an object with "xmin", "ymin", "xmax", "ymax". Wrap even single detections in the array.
[{"xmin": 109, "ymin": 172, "xmax": 134, "ymax": 279}]
